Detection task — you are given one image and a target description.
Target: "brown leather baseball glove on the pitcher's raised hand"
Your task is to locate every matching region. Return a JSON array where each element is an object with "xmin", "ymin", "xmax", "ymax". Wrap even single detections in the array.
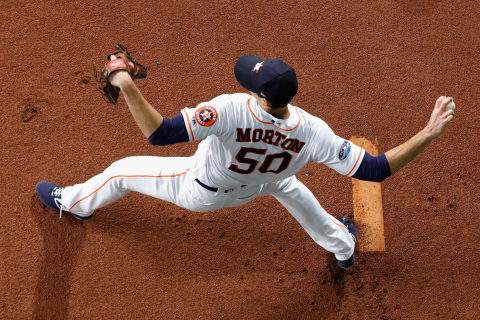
[{"xmin": 93, "ymin": 44, "xmax": 148, "ymax": 106}]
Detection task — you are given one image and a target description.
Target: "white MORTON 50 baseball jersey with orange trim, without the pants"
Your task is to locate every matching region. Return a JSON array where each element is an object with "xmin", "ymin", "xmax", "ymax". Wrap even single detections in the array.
[{"xmin": 182, "ymin": 93, "xmax": 364, "ymax": 187}]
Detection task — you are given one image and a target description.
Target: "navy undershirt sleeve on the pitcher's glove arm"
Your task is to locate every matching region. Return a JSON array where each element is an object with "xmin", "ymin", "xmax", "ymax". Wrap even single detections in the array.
[{"xmin": 148, "ymin": 114, "xmax": 189, "ymax": 146}]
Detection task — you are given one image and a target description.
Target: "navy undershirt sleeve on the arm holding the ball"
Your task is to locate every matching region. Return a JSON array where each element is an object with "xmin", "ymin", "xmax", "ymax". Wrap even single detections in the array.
[{"xmin": 352, "ymin": 151, "xmax": 392, "ymax": 182}]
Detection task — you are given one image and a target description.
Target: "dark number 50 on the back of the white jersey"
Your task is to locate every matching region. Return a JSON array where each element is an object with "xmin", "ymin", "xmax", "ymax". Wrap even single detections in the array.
[{"xmin": 228, "ymin": 147, "xmax": 292, "ymax": 174}]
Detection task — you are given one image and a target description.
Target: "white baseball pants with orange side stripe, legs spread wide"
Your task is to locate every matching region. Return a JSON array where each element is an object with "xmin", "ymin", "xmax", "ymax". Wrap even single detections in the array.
[{"xmin": 61, "ymin": 157, "xmax": 355, "ymax": 260}]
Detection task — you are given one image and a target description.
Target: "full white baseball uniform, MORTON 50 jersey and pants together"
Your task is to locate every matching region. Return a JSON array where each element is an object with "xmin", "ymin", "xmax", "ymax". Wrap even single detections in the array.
[{"xmin": 61, "ymin": 93, "xmax": 365, "ymax": 260}]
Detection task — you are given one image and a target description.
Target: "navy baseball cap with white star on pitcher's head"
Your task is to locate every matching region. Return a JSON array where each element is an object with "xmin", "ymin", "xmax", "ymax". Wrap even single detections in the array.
[{"xmin": 234, "ymin": 55, "xmax": 298, "ymax": 107}]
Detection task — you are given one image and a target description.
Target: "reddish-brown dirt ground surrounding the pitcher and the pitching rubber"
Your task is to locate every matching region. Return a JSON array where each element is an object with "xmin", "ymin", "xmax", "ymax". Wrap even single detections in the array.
[{"xmin": 0, "ymin": 0, "xmax": 480, "ymax": 320}]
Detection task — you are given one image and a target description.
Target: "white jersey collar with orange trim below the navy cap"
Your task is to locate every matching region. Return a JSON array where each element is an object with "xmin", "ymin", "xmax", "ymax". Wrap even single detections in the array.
[{"xmin": 248, "ymin": 97, "xmax": 301, "ymax": 131}]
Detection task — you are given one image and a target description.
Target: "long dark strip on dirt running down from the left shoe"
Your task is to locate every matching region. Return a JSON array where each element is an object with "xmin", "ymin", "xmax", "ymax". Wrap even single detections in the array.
[{"xmin": 30, "ymin": 195, "xmax": 86, "ymax": 319}]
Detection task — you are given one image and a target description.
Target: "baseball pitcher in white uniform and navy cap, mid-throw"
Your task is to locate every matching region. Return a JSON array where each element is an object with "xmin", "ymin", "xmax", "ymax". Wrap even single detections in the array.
[{"xmin": 36, "ymin": 50, "xmax": 453, "ymax": 268}]
